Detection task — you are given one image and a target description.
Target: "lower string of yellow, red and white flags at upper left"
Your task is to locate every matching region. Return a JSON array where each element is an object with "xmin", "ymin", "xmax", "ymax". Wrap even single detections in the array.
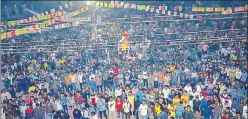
[{"xmin": 1, "ymin": 7, "xmax": 88, "ymax": 40}]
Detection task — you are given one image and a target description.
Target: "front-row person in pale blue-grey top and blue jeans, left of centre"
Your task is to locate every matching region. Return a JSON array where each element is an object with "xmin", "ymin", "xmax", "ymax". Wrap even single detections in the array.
[{"xmin": 97, "ymin": 96, "xmax": 108, "ymax": 119}]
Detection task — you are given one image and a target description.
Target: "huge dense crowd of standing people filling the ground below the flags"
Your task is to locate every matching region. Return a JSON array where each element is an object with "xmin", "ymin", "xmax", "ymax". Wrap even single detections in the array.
[{"xmin": 0, "ymin": 3, "xmax": 248, "ymax": 119}]
